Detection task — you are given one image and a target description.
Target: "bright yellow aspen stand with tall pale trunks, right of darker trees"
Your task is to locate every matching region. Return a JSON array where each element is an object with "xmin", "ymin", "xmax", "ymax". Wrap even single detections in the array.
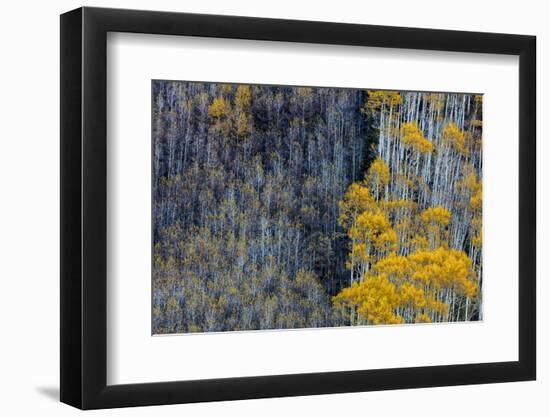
[{"xmin": 333, "ymin": 92, "xmax": 482, "ymax": 324}]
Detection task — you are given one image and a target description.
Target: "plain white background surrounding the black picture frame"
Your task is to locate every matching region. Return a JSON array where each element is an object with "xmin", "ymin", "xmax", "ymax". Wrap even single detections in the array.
[{"xmin": 0, "ymin": 0, "xmax": 550, "ymax": 417}]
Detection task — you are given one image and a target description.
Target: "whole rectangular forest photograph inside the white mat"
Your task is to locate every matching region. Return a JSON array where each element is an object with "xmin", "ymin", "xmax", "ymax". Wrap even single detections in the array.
[{"xmin": 152, "ymin": 80, "xmax": 483, "ymax": 334}]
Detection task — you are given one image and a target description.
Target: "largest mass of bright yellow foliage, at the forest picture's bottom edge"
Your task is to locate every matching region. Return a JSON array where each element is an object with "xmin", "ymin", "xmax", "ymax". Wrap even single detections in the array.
[{"xmin": 333, "ymin": 247, "xmax": 478, "ymax": 324}]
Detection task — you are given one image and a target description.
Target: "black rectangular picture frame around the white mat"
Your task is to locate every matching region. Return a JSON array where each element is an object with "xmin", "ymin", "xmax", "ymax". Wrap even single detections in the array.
[{"xmin": 60, "ymin": 7, "xmax": 536, "ymax": 409}]
